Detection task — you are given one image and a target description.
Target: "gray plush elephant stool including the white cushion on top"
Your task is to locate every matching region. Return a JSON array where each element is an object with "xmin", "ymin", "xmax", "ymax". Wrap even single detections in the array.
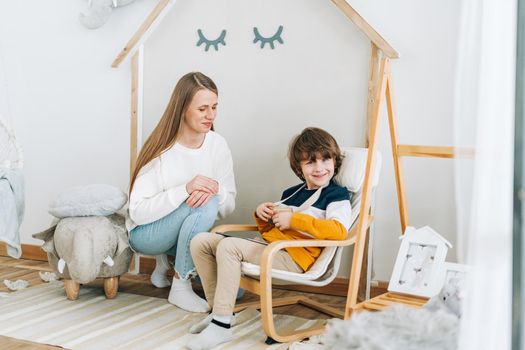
[{"xmin": 33, "ymin": 185, "xmax": 133, "ymax": 300}]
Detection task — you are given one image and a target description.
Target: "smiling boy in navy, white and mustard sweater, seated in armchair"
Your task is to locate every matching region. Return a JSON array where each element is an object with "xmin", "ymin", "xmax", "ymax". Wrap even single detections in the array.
[{"xmin": 187, "ymin": 128, "xmax": 351, "ymax": 350}]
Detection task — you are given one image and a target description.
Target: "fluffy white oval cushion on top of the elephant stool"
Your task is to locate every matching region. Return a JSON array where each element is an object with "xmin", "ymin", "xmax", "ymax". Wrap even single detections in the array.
[{"xmin": 49, "ymin": 184, "xmax": 128, "ymax": 218}]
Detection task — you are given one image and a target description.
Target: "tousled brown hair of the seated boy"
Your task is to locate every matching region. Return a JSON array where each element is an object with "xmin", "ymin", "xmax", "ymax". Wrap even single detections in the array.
[{"xmin": 288, "ymin": 127, "xmax": 343, "ymax": 181}]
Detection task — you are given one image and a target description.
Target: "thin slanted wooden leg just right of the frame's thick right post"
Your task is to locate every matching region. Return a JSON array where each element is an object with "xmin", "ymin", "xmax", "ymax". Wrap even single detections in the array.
[{"xmin": 385, "ymin": 76, "xmax": 408, "ymax": 234}]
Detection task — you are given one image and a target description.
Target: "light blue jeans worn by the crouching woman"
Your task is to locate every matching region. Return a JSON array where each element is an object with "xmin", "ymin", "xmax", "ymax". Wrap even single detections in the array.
[{"xmin": 129, "ymin": 196, "xmax": 219, "ymax": 279}]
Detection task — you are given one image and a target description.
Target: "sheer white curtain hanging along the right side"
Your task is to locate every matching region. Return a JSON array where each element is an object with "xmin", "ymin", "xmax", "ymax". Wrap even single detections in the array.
[{"xmin": 454, "ymin": 0, "xmax": 516, "ymax": 350}]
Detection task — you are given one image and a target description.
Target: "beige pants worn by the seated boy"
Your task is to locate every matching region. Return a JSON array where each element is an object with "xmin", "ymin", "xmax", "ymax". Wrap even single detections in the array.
[{"xmin": 190, "ymin": 232, "xmax": 303, "ymax": 316}]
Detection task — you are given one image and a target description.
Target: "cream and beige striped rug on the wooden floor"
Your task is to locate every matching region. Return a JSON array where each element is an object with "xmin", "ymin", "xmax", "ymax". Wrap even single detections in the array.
[{"xmin": 0, "ymin": 282, "xmax": 324, "ymax": 350}]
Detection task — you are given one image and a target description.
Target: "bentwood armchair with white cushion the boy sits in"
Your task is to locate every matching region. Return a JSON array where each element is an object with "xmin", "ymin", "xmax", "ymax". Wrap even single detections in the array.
[{"xmin": 212, "ymin": 148, "xmax": 380, "ymax": 342}]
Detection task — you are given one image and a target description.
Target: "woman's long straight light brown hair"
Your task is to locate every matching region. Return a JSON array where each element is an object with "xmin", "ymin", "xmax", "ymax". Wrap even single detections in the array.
[{"xmin": 129, "ymin": 72, "xmax": 218, "ymax": 194}]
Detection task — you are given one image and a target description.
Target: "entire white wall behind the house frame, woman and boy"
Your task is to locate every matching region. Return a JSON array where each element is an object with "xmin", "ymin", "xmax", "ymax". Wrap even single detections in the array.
[{"xmin": 0, "ymin": 0, "xmax": 459, "ymax": 280}]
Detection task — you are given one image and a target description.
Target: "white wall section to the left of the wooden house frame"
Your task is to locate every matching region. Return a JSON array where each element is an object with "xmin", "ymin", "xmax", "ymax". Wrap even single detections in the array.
[{"xmin": 0, "ymin": 0, "xmax": 154, "ymax": 244}]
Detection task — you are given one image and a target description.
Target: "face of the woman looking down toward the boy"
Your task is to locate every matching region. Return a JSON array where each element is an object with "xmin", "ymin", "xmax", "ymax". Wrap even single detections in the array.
[{"xmin": 183, "ymin": 89, "xmax": 217, "ymax": 134}]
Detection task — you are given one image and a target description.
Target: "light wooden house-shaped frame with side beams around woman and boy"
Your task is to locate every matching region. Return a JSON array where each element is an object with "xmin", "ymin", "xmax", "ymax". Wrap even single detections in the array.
[{"xmin": 112, "ymin": 0, "xmax": 454, "ymax": 342}]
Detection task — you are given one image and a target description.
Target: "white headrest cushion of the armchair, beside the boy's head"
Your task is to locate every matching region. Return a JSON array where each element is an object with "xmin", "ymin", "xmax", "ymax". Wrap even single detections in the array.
[{"xmin": 334, "ymin": 147, "xmax": 381, "ymax": 192}]
